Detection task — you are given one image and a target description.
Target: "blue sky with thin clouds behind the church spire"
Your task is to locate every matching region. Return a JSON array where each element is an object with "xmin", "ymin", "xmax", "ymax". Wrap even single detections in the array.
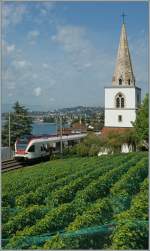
[{"xmin": 2, "ymin": 1, "xmax": 148, "ymax": 110}]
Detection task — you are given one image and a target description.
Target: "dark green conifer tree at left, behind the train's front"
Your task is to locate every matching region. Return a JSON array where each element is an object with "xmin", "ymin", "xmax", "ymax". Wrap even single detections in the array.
[{"xmin": 2, "ymin": 102, "xmax": 33, "ymax": 146}]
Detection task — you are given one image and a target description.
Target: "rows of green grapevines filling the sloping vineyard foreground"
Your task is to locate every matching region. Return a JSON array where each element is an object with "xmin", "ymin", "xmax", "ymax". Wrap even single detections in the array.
[{"xmin": 2, "ymin": 152, "xmax": 148, "ymax": 249}]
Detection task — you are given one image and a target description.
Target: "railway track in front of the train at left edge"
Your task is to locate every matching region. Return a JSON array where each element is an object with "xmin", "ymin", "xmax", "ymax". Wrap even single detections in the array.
[{"xmin": 1, "ymin": 159, "xmax": 26, "ymax": 172}]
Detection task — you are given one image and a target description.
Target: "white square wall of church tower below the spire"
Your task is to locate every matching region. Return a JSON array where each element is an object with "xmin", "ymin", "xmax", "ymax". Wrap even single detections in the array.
[{"xmin": 104, "ymin": 87, "xmax": 140, "ymax": 127}]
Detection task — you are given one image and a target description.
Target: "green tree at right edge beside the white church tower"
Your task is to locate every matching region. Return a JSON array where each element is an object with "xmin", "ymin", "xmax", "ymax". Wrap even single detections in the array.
[{"xmin": 133, "ymin": 94, "xmax": 149, "ymax": 149}]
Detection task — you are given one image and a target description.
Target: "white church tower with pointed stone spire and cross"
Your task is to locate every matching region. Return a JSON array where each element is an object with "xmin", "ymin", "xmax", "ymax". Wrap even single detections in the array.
[{"xmin": 103, "ymin": 15, "xmax": 141, "ymax": 131}]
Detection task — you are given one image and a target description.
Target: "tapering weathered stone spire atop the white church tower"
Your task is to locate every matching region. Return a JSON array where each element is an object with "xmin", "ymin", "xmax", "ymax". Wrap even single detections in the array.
[{"xmin": 112, "ymin": 17, "xmax": 135, "ymax": 87}]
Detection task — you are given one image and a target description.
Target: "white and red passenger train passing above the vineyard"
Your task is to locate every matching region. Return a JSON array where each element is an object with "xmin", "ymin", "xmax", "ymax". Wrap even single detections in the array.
[{"xmin": 14, "ymin": 133, "xmax": 87, "ymax": 160}]
